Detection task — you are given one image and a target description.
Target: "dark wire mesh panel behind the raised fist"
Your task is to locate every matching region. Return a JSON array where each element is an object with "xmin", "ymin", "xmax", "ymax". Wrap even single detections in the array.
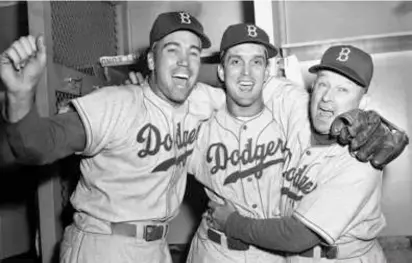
[{"xmin": 50, "ymin": 1, "xmax": 117, "ymax": 75}]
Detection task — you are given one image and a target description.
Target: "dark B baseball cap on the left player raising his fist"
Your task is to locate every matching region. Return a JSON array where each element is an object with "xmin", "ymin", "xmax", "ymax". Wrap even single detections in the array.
[{"xmin": 149, "ymin": 11, "xmax": 211, "ymax": 48}]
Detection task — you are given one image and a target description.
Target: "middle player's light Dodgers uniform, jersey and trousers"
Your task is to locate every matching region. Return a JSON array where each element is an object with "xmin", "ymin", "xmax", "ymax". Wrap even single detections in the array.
[{"xmin": 187, "ymin": 78, "xmax": 308, "ymax": 263}]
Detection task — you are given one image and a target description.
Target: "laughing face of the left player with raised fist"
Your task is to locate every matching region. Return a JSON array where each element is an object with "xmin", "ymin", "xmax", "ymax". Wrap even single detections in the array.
[{"xmin": 148, "ymin": 30, "xmax": 202, "ymax": 105}]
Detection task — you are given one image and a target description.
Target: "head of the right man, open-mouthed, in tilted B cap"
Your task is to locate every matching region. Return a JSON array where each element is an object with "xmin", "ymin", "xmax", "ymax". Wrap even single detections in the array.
[{"xmin": 309, "ymin": 46, "xmax": 373, "ymax": 138}]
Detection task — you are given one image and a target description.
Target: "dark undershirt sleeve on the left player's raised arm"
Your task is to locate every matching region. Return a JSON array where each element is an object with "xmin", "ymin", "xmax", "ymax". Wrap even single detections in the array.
[{"xmin": 6, "ymin": 105, "xmax": 86, "ymax": 165}]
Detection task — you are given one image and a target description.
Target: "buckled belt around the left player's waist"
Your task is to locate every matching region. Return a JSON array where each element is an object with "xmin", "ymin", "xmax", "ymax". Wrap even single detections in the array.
[{"xmin": 110, "ymin": 222, "xmax": 168, "ymax": 242}]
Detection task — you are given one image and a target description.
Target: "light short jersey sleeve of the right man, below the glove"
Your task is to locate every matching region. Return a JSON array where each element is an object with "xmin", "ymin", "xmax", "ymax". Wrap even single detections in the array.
[{"xmin": 293, "ymin": 163, "xmax": 381, "ymax": 244}]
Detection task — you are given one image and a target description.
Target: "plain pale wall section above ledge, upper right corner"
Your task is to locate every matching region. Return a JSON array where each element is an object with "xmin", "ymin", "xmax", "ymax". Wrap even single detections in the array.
[{"xmin": 273, "ymin": 1, "xmax": 412, "ymax": 44}]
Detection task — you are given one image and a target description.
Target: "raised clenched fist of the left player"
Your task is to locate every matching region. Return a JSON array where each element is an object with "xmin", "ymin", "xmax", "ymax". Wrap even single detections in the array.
[{"xmin": 0, "ymin": 35, "xmax": 46, "ymax": 98}]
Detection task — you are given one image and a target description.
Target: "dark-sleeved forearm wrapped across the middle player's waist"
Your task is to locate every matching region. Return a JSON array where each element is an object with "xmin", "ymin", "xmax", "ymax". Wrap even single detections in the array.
[{"xmin": 225, "ymin": 213, "xmax": 321, "ymax": 253}]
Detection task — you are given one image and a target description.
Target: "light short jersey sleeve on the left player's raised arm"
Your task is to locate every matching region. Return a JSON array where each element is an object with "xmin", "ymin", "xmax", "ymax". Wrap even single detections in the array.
[{"xmin": 72, "ymin": 86, "xmax": 141, "ymax": 156}]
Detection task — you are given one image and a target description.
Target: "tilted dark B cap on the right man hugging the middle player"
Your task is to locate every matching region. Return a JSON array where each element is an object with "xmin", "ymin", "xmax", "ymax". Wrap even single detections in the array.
[{"xmin": 308, "ymin": 45, "xmax": 373, "ymax": 88}]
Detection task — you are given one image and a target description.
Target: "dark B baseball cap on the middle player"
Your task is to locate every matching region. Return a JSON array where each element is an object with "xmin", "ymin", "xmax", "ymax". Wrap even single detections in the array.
[{"xmin": 220, "ymin": 23, "xmax": 278, "ymax": 58}]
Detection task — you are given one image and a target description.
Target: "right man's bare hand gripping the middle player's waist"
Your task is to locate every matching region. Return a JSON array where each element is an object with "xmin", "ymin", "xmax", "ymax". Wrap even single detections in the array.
[{"xmin": 208, "ymin": 200, "xmax": 237, "ymax": 231}]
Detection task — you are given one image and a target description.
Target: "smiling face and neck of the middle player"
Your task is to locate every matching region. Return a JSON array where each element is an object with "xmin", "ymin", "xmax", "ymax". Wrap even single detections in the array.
[{"xmin": 218, "ymin": 43, "xmax": 268, "ymax": 116}]
